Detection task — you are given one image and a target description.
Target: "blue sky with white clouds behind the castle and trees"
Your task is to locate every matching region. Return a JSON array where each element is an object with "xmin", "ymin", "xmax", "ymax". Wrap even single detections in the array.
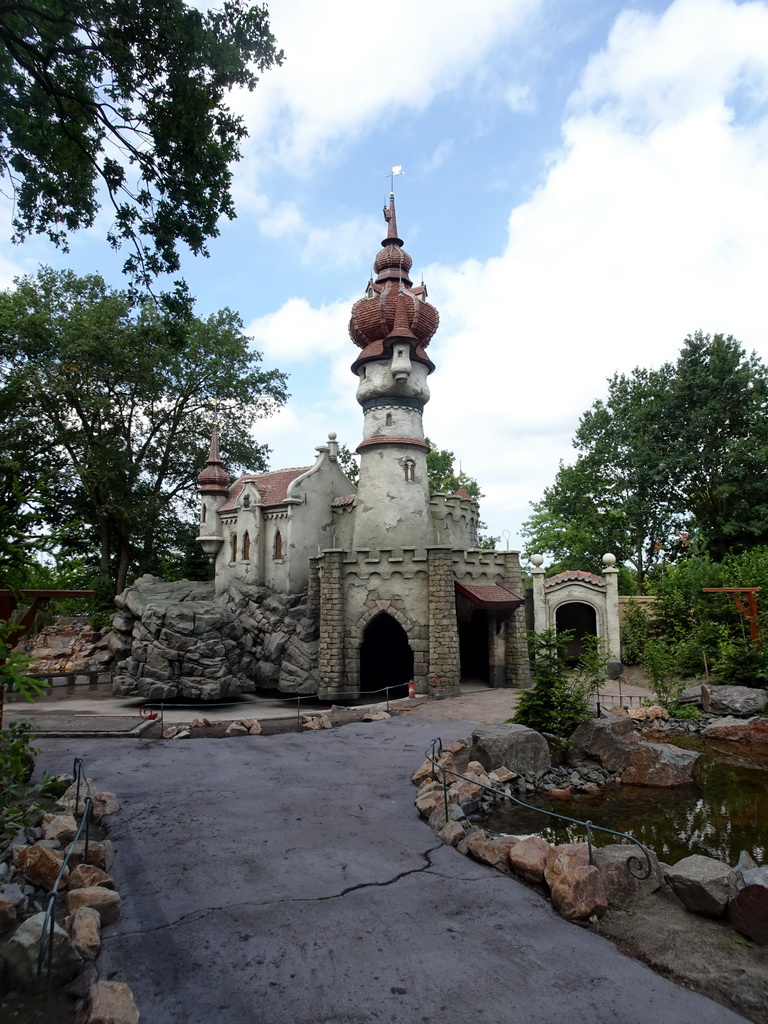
[{"xmin": 0, "ymin": 0, "xmax": 768, "ymax": 546}]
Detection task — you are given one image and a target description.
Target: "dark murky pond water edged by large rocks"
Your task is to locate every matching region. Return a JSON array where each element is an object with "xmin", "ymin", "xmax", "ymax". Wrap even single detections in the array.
[{"xmin": 481, "ymin": 735, "xmax": 768, "ymax": 864}]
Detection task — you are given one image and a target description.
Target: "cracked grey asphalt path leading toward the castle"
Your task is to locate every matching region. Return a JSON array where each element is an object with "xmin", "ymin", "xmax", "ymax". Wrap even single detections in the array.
[{"xmin": 38, "ymin": 716, "xmax": 744, "ymax": 1024}]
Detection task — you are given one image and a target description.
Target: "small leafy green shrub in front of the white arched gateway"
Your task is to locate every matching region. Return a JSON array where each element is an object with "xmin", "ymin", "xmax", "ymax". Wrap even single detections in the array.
[{"xmin": 514, "ymin": 630, "xmax": 608, "ymax": 736}]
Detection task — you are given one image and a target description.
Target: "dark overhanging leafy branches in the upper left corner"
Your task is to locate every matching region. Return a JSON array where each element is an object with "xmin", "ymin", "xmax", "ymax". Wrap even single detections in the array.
[{"xmin": 0, "ymin": 0, "xmax": 283, "ymax": 284}]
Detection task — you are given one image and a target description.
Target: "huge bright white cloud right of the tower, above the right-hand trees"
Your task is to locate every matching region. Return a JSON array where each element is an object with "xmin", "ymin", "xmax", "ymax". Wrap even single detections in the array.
[{"xmin": 426, "ymin": 0, "xmax": 768, "ymax": 532}]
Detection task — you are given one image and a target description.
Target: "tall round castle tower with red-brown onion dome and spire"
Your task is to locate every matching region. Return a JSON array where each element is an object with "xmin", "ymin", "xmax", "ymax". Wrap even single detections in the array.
[{"xmin": 349, "ymin": 193, "xmax": 439, "ymax": 550}]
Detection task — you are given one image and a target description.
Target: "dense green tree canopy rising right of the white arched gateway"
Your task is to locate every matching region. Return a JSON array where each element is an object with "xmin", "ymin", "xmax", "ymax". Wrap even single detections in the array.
[{"xmin": 523, "ymin": 331, "xmax": 768, "ymax": 591}]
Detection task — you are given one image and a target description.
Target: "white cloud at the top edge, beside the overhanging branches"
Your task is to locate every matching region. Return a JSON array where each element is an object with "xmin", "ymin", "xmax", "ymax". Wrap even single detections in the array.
[{"xmin": 232, "ymin": 0, "xmax": 542, "ymax": 173}]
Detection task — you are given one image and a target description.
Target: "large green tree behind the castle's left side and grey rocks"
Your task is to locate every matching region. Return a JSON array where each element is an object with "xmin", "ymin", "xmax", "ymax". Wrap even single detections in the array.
[{"xmin": 0, "ymin": 268, "xmax": 287, "ymax": 592}]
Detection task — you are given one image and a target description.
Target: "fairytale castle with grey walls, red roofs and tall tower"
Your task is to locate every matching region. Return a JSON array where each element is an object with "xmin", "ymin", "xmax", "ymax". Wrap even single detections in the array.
[{"xmin": 198, "ymin": 194, "xmax": 529, "ymax": 697}]
